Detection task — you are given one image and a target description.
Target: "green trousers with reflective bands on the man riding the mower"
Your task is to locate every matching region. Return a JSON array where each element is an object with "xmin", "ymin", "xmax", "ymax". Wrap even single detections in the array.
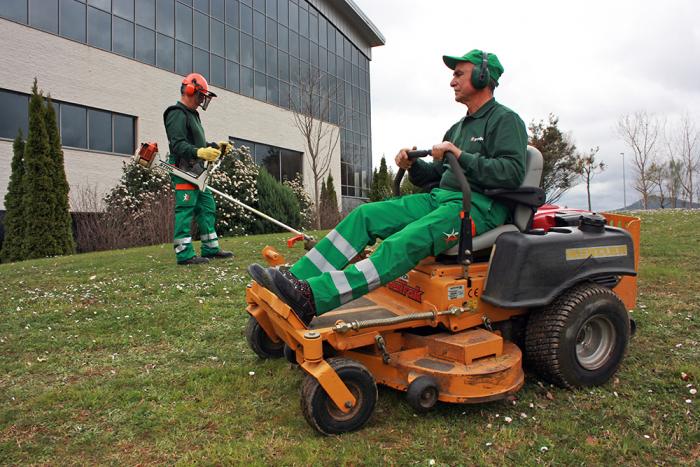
[{"xmin": 291, "ymin": 188, "xmax": 508, "ymax": 315}]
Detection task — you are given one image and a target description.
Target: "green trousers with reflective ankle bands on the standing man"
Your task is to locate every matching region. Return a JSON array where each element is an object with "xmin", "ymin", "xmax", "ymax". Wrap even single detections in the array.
[{"xmin": 172, "ymin": 177, "xmax": 219, "ymax": 262}]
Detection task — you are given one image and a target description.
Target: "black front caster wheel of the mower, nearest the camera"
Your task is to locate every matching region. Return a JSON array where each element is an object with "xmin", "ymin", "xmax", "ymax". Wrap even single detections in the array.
[{"xmin": 301, "ymin": 358, "xmax": 377, "ymax": 435}]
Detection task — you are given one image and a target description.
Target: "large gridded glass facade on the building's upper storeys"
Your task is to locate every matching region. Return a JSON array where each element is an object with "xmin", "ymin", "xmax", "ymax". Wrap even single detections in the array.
[{"xmin": 0, "ymin": 0, "xmax": 372, "ymax": 198}]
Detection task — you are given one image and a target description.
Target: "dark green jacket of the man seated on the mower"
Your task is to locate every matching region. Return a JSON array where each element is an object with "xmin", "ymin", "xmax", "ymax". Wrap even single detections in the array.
[{"xmin": 409, "ymin": 98, "xmax": 527, "ymax": 193}]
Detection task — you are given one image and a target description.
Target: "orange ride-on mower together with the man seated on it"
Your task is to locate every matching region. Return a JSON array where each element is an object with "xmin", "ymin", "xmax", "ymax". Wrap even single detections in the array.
[{"xmin": 246, "ymin": 50, "xmax": 639, "ymax": 434}]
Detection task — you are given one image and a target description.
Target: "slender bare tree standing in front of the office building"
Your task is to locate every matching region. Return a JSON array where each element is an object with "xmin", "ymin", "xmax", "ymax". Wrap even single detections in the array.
[{"xmin": 289, "ymin": 69, "xmax": 343, "ymax": 229}]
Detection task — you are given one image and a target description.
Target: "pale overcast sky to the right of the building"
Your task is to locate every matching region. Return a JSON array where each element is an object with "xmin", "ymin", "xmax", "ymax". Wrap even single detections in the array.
[{"xmin": 354, "ymin": 0, "xmax": 700, "ymax": 210}]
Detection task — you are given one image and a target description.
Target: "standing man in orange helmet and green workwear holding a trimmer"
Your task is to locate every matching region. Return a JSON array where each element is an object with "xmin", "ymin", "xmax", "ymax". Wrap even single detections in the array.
[{"xmin": 163, "ymin": 73, "xmax": 233, "ymax": 265}]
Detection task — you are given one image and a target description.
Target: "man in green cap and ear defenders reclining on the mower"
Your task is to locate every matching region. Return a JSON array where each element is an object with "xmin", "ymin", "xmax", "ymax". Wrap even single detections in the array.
[{"xmin": 248, "ymin": 49, "xmax": 527, "ymax": 324}]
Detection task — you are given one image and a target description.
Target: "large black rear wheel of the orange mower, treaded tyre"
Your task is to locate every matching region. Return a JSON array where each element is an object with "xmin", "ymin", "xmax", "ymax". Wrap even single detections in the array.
[{"xmin": 525, "ymin": 282, "xmax": 630, "ymax": 388}]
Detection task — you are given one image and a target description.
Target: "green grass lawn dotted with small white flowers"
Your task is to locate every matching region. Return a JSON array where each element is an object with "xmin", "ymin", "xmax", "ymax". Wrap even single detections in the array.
[{"xmin": 0, "ymin": 211, "xmax": 700, "ymax": 465}]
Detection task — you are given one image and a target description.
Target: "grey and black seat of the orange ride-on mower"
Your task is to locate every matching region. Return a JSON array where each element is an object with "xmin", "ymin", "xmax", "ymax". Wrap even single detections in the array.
[{"xmin": 442, "ymin": 146, "xmax": 545, "ymax": 257}]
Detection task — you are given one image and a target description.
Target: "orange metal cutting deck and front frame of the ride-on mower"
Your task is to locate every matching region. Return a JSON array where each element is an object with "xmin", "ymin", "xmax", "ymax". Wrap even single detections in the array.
[{"xmin": 247, "ymin": 261, "xmax": 524, "ymax": 410}]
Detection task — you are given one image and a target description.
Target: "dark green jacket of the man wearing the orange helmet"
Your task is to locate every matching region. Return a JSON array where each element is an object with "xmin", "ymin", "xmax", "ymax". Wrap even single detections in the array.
[{"xmin": 163, "ymin": 102, "xmax": 207, "ymax": 164}]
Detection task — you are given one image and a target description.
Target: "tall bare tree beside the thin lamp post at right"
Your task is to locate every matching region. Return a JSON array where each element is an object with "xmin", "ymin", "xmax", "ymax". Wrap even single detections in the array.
[{"xmin": 617, "ymin": 111, "xmax": 661, "ymax": 209}]
